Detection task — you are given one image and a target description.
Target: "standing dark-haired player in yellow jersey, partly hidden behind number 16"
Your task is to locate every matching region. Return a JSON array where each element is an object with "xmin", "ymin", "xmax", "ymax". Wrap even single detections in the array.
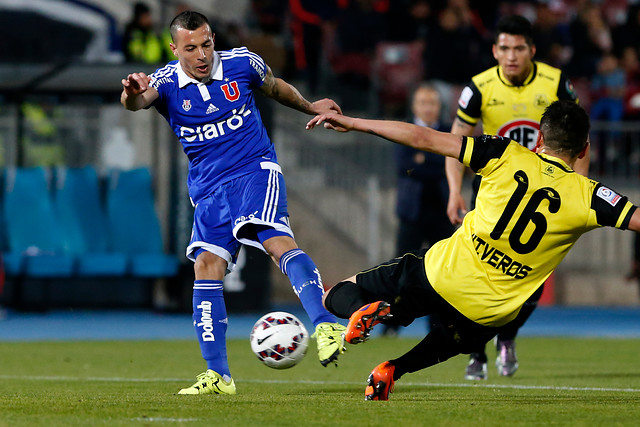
[{"xmin": 446, "ymin": 16, "xmax": 589, "ymax": 380}]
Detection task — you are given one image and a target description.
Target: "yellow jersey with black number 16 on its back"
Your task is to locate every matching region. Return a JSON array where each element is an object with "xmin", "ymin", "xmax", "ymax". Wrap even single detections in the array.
[{"xmin": 425, "ymin": 135, "xmax": 636, "ymax": 326}]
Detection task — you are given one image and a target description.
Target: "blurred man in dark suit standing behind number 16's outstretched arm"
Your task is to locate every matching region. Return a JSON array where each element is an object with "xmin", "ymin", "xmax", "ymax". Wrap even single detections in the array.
[{"xmin": 383, "ymin": 83, "xmax": 455, "ymax": 335}]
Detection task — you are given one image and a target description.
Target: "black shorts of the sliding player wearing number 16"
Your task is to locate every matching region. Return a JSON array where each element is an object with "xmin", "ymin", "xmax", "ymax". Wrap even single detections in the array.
[{"xmin": 356, "ymin": 249, "xmax": 498, "ymax": 352}]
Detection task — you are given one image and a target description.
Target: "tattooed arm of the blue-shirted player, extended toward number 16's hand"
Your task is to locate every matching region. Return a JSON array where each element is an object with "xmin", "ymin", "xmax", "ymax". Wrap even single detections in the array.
[{"xmin": 260, "ymin": 66, "xmax": 342, "ymax": 115}]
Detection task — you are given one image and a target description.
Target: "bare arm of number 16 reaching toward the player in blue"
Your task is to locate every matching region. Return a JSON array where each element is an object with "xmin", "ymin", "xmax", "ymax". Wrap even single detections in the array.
[{"xmin": 307, "ymin": 113, "xmax": 464, "ymax": 158}]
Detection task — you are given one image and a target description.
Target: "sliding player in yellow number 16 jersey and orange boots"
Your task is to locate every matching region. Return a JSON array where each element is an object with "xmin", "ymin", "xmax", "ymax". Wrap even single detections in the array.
[{"xmin": 307, "ymin": 101, "xmax": 640, "ymax": 400}]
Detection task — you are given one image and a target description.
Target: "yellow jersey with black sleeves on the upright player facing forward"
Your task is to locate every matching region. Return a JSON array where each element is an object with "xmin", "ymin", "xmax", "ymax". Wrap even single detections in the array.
[{"xmin": 456, "ymin": 62, "xmax": 578, "ymax": 149}]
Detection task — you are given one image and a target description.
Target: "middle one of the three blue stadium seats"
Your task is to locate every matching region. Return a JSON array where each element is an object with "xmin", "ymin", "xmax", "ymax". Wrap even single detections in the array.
[{"xmin": 54, "ymin": 166, "xmax": 127, "ymax": 276}]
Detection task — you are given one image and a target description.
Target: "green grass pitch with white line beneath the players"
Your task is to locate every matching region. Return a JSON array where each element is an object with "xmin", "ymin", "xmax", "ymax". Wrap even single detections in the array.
[{"xmin": 0, "ymin": 337, "xmax": 640, "ymax": 427}]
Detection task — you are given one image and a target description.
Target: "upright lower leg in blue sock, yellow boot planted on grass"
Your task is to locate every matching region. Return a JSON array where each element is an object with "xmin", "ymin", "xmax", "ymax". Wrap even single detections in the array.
[{"xmin": 178, "ymin": 280, "xmax": 236, "ymax": 394}]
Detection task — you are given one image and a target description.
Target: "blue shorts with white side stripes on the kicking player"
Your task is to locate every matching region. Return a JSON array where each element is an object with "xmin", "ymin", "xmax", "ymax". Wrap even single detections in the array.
[{"xmin": 187, "ymin": 162, "xmax": 293, "ymax": 271}]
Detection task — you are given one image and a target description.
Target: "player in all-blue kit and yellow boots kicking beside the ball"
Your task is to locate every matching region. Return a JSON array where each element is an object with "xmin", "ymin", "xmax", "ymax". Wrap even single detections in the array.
[{"xmin": 121, "ymin": 11, "xmax": 345, "ymax": 394}]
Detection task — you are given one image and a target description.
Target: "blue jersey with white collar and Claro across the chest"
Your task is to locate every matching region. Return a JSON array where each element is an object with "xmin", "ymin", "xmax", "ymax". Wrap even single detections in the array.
[{"xmin": 151, "ymin": 47, "xmax": 277, "ymax": 203}]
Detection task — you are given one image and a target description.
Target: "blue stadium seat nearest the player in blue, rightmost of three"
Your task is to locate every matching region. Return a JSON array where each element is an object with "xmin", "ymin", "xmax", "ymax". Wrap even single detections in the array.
[{"xmin": 107, "ymin": 168, "xmax": 178, "ymax": 277}]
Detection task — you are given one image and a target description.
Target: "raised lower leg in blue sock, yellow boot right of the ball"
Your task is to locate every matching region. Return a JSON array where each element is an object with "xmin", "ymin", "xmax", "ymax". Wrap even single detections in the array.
[{"xmin": 280, "ymin": 248, "xmax": 345, "ymax": 366}]
